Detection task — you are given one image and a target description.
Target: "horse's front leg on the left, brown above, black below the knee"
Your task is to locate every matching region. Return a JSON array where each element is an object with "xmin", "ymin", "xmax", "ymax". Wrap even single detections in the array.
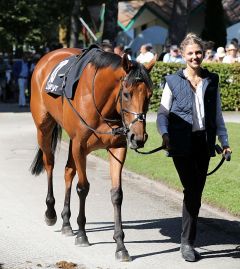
[{"xmin": 72, "ymin": 140, "xmax": 90, "ymax": 247}]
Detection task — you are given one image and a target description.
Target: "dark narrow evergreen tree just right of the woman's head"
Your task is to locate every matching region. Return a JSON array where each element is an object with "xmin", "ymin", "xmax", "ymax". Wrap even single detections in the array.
[{"xmin": 202, "ymin": 0, "xmax": 227, "ymax": 48}]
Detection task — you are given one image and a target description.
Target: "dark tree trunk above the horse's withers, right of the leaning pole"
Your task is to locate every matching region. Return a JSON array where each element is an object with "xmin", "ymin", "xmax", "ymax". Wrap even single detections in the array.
[{"xmin": 102, "ymin": 0, "xmax": 118, "ymax": 45}]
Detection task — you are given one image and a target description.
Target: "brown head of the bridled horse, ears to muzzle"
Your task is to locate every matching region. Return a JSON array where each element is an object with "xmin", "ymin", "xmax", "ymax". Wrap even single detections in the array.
[{"xmin": 120, "ymin": 55, "xmax": 156, "ymax": 149}]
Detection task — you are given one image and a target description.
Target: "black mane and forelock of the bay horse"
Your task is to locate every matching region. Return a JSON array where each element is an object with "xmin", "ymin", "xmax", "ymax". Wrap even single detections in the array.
[{"xmin": 90, "ymin": 51, "xmax": 153, "ymax": 89}]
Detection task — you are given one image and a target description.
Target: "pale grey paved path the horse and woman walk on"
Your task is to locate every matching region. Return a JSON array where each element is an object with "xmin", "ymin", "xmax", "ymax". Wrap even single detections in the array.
[{"xmin": 0, "ymin": 109, "xmax": 240, "ymax": 269}]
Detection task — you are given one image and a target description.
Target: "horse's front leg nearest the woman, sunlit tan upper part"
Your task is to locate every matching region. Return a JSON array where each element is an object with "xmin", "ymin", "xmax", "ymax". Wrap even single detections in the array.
[{"xmin": 109, "ymin": 148, "xmax": 131, "ymax": 261}]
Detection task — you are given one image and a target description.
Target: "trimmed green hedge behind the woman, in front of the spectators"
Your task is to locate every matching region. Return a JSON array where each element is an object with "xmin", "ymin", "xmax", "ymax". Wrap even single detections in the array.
[{"xmin": 149, "ymin": 62, "xmax": 240, "ymax": 112}]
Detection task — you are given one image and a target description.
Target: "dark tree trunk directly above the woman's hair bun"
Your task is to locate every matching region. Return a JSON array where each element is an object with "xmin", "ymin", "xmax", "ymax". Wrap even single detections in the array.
[{"xmin": 169, "ymin": 0, "xmax": 191, "ymax": 45}]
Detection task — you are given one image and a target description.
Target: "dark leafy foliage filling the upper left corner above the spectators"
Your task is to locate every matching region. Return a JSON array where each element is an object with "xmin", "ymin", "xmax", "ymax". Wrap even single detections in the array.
[{"xmin": 0, "ymin": 0, "xmax": 72, "ymax": 51}]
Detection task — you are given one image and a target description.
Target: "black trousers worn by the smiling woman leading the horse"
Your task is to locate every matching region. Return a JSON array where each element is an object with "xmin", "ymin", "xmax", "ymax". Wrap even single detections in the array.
[{"xmin": 173, "ymin": 131, "xmax": 210, "ymax": 245}]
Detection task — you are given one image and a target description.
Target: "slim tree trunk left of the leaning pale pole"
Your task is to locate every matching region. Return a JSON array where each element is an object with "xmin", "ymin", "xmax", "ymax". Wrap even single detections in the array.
[{"xmin": 70, "ymin": 0, "xmax": 82, "ymax": 48}]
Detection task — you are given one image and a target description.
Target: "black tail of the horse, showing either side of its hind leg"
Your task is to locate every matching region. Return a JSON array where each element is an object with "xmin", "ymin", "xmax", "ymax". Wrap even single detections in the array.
[{"xmin": 30, "ymin": 124, "xmax": 62, "ymax": 176}]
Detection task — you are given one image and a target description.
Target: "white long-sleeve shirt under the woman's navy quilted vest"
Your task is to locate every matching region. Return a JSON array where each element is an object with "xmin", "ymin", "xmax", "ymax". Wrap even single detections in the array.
[{"xmin": 157, "ymin": 82, "xmax": 229, "ymax": 146}]
